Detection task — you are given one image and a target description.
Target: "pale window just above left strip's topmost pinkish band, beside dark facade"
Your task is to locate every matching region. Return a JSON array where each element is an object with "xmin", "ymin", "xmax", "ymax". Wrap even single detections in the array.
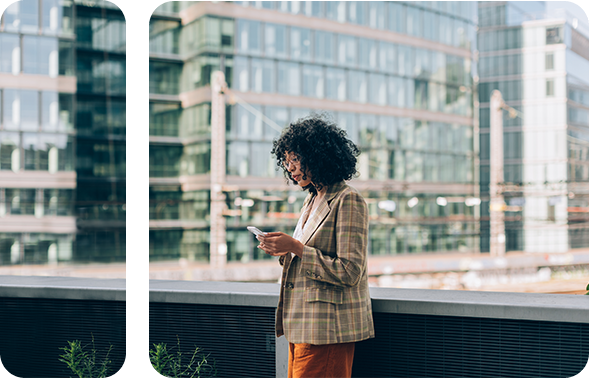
[{"xmin": 23, "ymin": 36, "xmax": 59, "ymax": 77}]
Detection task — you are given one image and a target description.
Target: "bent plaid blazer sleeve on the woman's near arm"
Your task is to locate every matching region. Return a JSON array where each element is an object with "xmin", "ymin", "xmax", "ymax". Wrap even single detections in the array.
[{"xmin": 301, "ymin": 191, "xmax": 368, "ymax": 286}]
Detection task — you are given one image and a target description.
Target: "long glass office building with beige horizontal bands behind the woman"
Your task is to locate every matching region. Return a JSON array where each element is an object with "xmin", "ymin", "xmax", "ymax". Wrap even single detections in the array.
[{"xmin": 0, "ymin": 0, "xmax": 479, "ymax": 264}]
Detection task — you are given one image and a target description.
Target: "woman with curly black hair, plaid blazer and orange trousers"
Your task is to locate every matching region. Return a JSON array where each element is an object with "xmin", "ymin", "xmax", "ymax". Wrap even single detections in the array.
[{"xmin": 258, "ymin": 117, "xmax": 374, "ymax": 378}]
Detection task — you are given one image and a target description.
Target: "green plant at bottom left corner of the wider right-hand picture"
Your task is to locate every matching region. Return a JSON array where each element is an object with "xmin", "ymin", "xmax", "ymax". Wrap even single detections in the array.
[{"xmin": 145, "ymin": 339, "xmax": 217, "ymax": 378}]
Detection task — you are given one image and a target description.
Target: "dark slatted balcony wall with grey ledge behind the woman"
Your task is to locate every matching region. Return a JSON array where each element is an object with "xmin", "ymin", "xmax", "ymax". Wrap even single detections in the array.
[{"xmin": 0, "ymin": 276, "xmax": 589, "ymax": 378}]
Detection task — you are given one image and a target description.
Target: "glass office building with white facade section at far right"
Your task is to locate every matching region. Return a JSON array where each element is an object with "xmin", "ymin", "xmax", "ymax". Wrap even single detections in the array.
[{"xmin": 478, "ymin": 0, "xmax": 589, "ymax": 252}]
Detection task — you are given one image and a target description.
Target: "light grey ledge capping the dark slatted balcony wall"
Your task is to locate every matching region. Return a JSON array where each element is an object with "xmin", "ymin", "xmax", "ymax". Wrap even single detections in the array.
[{"xmin": 0, "ymin": 276, "xmax": 589, "ymax": 323}]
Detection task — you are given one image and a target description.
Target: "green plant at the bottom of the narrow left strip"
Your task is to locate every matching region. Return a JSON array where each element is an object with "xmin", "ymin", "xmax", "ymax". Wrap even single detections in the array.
[{"xmin": 59, "ymin": 335, "xmax": 113, "ymax": 378}]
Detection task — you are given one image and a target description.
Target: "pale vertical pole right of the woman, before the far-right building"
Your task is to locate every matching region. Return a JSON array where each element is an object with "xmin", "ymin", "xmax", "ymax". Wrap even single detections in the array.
[{"xmin": 489, "ymin": 90, "xmax": 505, "ymax": 257}]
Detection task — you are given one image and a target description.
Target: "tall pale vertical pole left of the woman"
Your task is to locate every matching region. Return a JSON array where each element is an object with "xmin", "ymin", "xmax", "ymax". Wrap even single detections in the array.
[{"xmin": 210, "ymin": 71, "xmax": 227, "ymax": 268}]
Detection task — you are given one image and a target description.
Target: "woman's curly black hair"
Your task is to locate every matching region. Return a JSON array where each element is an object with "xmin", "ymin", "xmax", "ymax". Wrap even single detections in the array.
[{"xmin": 272, "ymin": 114, "xmax": 360, "ymax": 193}]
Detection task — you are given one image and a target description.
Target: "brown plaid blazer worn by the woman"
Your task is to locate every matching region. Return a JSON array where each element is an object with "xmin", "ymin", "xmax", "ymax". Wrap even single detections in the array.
[{"xmin": 276, "ymin": 181, "xmax": 374, "ymax": 345}]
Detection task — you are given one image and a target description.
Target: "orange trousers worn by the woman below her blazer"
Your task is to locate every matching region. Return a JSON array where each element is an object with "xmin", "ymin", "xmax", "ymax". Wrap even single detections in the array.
[{"xmin": 288, "ymin": 343, "xmax": 356, "ymax": 378}]
